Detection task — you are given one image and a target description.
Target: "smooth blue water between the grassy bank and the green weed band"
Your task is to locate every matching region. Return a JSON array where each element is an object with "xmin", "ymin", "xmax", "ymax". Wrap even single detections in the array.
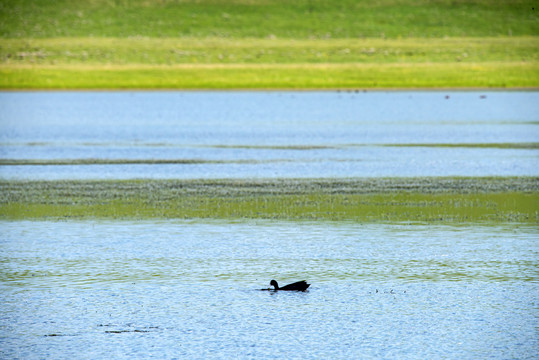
[{"xmin": 0, "ymin": 91, "xmax": 539, "ymax": 179}]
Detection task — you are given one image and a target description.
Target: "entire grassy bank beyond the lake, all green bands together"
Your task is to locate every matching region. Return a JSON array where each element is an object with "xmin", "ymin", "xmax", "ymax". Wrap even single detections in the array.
[{"xmin": 0, "ymin": 0, "xmax": 539, "ymax": 89}]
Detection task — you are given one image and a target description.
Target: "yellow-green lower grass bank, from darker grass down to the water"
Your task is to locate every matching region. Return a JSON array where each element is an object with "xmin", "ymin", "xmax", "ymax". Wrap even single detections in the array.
[{"xmin": 0, "ymin": 37, "xmax": 539, "ymax": 89}]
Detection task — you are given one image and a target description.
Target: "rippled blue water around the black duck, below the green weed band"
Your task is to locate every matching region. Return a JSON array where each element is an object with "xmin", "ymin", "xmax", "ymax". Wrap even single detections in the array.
[{"xmin": 0, "ymin": 221, "xmax": 539, "ymax": 359}]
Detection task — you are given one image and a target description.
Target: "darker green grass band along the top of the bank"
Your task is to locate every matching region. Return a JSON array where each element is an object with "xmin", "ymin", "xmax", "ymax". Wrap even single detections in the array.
[{"xmin": 0, "ymin": 0, "xmax": 539, "ymax": 39}]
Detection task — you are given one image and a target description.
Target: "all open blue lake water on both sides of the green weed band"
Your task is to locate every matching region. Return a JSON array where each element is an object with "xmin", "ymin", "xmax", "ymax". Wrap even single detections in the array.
[{"xmin": 0, "ymin": 91, "xmax": 539, "ymax": 359}]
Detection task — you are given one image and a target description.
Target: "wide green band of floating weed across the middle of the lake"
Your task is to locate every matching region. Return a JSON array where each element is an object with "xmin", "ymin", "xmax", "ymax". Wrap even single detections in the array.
[{"xmin": 0, "ymin": 178, "xmax": 539, "ymax": 224}]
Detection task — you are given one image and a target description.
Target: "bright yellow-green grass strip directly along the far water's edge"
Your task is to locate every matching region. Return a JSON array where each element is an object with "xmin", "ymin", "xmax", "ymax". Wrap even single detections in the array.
[{"xmin": 0, "ymin": 62, "xmax": 539, "ymax": 89}]
